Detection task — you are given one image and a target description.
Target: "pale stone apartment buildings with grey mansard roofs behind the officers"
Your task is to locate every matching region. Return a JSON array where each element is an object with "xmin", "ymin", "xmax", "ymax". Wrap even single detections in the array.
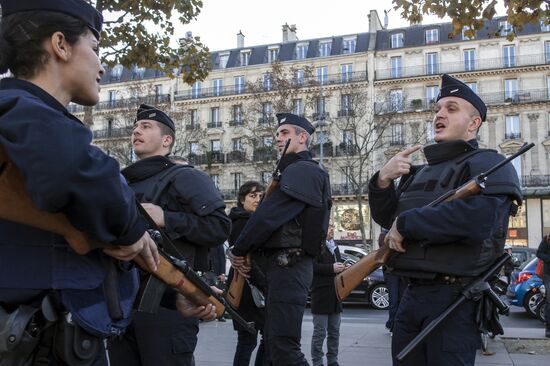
[{"xmin": 75, "ymin": 11, "xmax": 550, "ymax": 247}]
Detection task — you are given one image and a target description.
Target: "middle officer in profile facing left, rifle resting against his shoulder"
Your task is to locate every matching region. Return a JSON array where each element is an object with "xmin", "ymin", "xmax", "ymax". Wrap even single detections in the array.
[{"xmin": 229, "ymin": 113, "xmax": 330, "ymax": 366}]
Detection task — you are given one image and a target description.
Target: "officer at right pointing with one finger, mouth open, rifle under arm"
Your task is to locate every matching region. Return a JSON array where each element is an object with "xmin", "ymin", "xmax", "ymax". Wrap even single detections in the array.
[{"xmin": 369, "ymin": 75, "xmax": 521, "ymax": 365}]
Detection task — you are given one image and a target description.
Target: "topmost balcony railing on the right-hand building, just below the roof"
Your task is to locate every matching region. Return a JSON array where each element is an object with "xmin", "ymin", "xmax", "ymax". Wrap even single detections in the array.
[{"xmin": 374, "ymin": 53, "xmax": 548, "ymax": 80}]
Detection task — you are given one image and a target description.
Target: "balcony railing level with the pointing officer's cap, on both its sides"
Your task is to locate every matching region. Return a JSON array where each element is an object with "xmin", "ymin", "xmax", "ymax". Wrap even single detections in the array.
[{"xmin": 374, "ymin": 89, "xmax": 550, "ymax": 114}]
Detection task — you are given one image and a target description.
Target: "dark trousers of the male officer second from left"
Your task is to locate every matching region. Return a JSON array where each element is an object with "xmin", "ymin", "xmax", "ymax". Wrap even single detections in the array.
[{"xmin": 108, "ymin": 307, "xmax": 199, "ymax": 366}]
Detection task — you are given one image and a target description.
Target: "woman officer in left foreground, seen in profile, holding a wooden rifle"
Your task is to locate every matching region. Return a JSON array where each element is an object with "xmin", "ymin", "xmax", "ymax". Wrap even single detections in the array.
[{"xmin": 0, "ymin": 0, "xmax": 158, "ymax": 366}]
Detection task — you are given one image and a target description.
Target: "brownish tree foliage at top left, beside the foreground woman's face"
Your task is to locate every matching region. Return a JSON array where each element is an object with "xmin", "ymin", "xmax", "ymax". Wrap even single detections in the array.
[{"xmin": 95, "ymin": 0, "xmax": 211, "ymax": 84}]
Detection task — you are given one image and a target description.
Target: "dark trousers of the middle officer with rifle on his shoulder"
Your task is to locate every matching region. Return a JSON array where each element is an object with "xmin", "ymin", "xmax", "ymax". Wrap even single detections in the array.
[{"xmin": 264, "ymin": 254, "xmax": 313, "ymax": 366}]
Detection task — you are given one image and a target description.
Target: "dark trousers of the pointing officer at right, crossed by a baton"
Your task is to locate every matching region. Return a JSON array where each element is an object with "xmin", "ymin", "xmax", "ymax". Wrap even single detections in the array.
[{"xmin": 392, "ymin": 284, "xmax": 481, "ymax": 366}]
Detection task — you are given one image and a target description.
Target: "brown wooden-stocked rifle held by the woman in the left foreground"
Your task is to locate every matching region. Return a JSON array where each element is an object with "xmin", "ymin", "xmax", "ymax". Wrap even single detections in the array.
[{"xmin": 0, "ymin": 146, "xmax": 253, "ymax": 331}]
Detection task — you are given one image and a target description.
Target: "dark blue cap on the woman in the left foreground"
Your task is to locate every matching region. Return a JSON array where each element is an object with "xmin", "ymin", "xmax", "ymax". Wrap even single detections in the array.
[{"xmin": 0, "ymin": 0, "xmax": 103, "ymax": 39}]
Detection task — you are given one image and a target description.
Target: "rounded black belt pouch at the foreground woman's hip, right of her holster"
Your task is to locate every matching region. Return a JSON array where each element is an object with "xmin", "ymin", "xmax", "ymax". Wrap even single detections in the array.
[{"xmin": 53, "ymin": 314, "xmax": 103, "ymax": 366}]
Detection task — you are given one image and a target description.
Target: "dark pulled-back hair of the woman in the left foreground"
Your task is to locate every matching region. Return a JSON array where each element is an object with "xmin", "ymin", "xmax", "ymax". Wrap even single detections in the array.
[{"xmin": 0, "ymin": 11, "xmax": 90, "ymax": 78}]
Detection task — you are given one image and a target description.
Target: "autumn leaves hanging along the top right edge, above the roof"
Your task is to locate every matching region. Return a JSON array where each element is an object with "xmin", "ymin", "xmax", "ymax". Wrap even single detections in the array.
[{"xmin": 392, "ymin": 0, "xmax": 550, "ymax": 40}]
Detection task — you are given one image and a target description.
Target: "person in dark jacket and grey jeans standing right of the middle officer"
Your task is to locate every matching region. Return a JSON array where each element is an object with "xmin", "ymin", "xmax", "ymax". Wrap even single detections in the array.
[{"xmin": 311, "ymin": 224, "xmax": 346, "ymax": 366}]
